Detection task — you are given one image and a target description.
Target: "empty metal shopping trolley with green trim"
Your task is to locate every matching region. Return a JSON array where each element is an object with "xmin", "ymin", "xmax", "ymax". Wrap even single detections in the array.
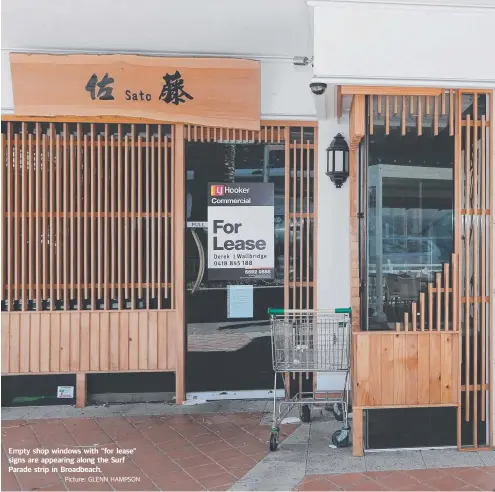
[{"xmin": 268, "ymin": 308, "xmax": 351, "ymax": 451}]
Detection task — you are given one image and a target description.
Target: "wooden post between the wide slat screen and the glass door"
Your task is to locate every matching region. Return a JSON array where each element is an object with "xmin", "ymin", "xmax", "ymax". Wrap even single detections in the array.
[{"xmin": 171, "ymin": 125, "xmax": 186, "ymax": 405}]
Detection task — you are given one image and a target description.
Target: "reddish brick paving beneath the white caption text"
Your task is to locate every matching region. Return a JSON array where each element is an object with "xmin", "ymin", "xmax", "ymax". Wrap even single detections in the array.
[{"xmin": 2, "ymin": 412, "xmax": 297, "ymax": 491}]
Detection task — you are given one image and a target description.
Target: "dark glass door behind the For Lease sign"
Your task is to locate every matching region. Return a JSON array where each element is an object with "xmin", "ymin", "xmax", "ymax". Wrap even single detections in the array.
[{"xmin": 186, "ymin": 142, "xmax": 285, "ymax": 392}]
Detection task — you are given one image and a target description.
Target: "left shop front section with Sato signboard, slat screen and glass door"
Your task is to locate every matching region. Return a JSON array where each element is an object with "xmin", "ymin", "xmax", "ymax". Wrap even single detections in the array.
[{"xmin": 2, "ymin": 25, "xmax": 317, "ymax": 406}]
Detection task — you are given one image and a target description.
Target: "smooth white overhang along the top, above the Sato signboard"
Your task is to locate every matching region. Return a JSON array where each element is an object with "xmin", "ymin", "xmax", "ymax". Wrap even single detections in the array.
[{"xmin": 2, "ymin": 0, "xmax": 312, "ymax": 58}]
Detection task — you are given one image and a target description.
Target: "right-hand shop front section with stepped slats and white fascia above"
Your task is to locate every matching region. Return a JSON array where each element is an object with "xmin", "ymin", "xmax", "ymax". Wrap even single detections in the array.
[{"xmin": 310, "ymin": 1, "xmax": 495, "ymax": 455}]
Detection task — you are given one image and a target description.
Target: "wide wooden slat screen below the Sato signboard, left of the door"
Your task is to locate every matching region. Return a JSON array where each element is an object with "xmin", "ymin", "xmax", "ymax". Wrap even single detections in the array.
[{"xmin": 2, "ymin": 122, "xmax": 174, "ymax": 311}]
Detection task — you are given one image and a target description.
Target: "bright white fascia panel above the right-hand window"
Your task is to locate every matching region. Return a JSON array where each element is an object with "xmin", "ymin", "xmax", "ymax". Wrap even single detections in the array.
[{"xmin": 310, "ymin": 0, "xmax": 495, "ymax": 88}]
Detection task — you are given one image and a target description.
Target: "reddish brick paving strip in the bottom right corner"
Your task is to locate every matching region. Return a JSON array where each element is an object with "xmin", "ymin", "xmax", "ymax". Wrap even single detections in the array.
[{"xmin": 295, "ymin": 466, "xmax": 495, "ymax": 491}]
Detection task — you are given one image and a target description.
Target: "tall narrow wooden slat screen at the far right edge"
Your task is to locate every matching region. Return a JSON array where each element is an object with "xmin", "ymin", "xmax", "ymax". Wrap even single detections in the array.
[{"xmin": 456, "ymin": 91, "xmax": 493, "ymax": 448}]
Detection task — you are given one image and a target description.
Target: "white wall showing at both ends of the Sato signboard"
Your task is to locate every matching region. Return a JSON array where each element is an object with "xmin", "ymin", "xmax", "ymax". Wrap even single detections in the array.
[{"xmin": 1, "ymin": 51, "xmax": 316, "ymax": 120}]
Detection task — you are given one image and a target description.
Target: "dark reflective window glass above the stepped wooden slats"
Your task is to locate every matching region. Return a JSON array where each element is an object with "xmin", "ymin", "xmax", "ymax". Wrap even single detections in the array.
[{"xmin": 367, "ymin": 99, "xmax": 454, "ymax": 330}]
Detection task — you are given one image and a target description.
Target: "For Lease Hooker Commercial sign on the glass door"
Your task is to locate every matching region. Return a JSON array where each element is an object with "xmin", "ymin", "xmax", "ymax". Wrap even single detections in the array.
[{"xmin": 208, "ymin": 183, "xmax": 275, "ymax": 280}]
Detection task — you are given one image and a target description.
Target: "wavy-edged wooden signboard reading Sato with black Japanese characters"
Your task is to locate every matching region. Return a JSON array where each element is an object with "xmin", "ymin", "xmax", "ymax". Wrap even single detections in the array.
[{"xmin": 10, "ymin": 53, "xmax": 260, "ymax": 130}]
